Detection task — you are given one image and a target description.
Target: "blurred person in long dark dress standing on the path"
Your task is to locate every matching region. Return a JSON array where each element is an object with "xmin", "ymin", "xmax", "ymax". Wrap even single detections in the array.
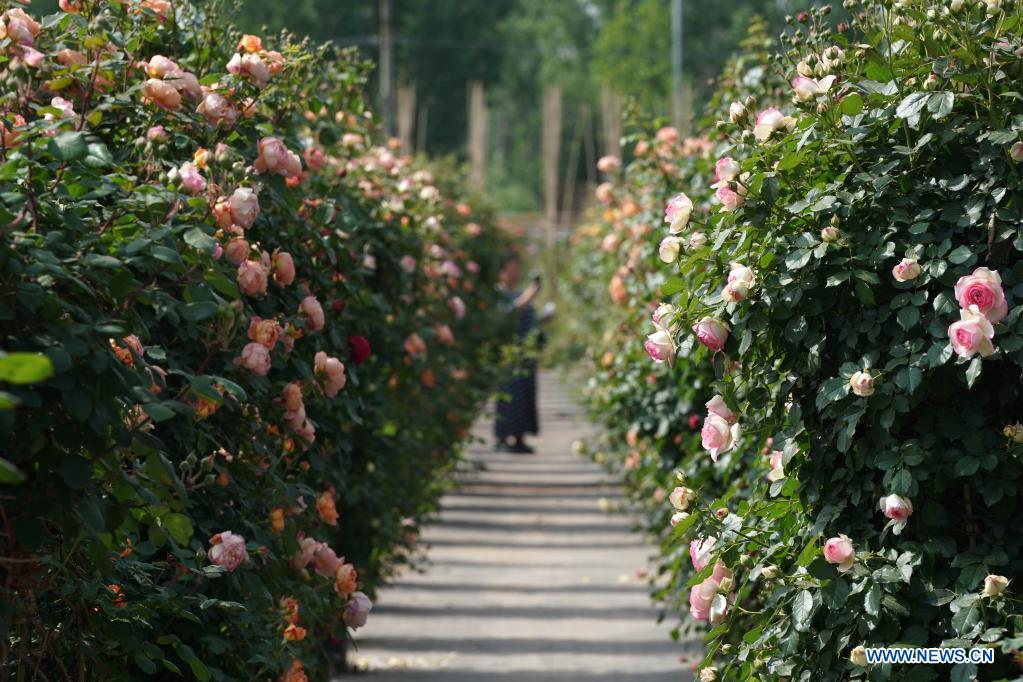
[{"xmin": 494, "ymin": 253, "xmax": 540, "ymax": 454}]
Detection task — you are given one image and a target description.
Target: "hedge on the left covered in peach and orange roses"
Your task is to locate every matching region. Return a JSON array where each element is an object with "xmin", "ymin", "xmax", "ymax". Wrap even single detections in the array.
[{"xmin": 0, "ymin": 0, "xmax": 508, "ymax": 682}]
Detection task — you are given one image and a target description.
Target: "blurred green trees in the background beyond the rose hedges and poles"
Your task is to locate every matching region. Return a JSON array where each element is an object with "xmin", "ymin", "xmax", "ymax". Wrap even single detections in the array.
[{"xmin": 226, "ymin": 0, "xmax": 811, "ymax": 212}]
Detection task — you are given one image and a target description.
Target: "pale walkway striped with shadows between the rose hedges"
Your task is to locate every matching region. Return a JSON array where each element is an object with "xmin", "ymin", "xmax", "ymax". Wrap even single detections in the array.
[{"xmin": 350, "ymin": 373, "xmax": 696, "ymax": 682}]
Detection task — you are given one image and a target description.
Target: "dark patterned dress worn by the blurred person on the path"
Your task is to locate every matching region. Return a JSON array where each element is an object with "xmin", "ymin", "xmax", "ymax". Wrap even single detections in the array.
[{"xmin": 494, "ymin": 291, "xmax": 540, "ymax": 441}]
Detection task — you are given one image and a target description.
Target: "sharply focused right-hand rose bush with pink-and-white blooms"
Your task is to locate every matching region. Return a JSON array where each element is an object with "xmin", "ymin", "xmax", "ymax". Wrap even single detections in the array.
[{"xmin": 572, "ymin": 0, "xmax": 1023, "ymax": 680}]
